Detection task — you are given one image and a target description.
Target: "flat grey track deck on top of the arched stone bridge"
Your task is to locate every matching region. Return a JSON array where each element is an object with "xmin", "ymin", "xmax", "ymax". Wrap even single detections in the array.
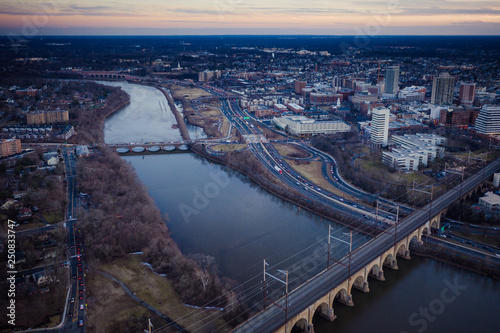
[{"xmin": 233, "ymin": 159, "xmax": 500, "ymax": 333}]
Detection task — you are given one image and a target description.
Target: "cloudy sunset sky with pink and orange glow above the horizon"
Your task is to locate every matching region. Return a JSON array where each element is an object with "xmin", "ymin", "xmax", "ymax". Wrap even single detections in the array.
[{"xmin": 0, "ymin": 0, "xmax": 500, "ymax": 37}]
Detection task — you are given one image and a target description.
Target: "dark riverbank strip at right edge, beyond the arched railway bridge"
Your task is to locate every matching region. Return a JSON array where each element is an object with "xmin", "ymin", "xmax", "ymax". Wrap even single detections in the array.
[{"xmin": 410, "ymin": 243, "xmax": 500, "ymax": 280}]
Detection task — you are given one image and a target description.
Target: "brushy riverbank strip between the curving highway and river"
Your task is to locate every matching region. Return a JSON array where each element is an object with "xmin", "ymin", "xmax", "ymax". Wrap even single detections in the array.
[{"xmin": 191, "ymin": 144, "xmax": 380, "ymax": 237}]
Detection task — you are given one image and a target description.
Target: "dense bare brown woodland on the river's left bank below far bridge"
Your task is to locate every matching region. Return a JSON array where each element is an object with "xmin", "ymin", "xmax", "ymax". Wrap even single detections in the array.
[{"xmin": 78, "ymin": 149, "xmax": 243, "ymax": 320}]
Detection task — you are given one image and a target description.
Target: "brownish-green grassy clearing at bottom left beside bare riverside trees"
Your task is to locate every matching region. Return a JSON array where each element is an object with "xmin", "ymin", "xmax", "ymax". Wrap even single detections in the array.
[{"xmin": 100, "ymin": 255, "xmax": 228, "ymax": 332}]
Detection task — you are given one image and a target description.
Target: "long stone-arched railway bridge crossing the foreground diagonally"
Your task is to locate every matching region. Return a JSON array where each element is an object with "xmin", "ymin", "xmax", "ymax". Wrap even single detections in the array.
[{"xmin": 232, "ymin": 159, "xmax": 500, "ymax": 333}]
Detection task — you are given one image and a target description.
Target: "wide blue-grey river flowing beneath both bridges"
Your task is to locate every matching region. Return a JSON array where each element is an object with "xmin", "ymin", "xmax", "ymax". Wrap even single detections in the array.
[{"xmin": 105, "ymin": 83, "xmax": 500, "ymax": 333}]
